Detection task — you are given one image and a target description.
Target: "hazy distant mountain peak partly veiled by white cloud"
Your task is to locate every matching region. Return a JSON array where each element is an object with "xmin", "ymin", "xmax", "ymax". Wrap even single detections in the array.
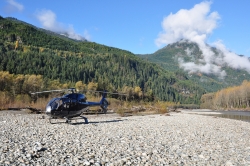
[{"xmin": 138, "ymin": 40, "xmax": 250, "ymax": 92}]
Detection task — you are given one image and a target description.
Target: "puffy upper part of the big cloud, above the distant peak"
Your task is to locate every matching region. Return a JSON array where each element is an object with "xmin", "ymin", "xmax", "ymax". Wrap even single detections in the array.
[{"xmin": 156, "ymin": 2, "xmax": 219, "ymax": 46}]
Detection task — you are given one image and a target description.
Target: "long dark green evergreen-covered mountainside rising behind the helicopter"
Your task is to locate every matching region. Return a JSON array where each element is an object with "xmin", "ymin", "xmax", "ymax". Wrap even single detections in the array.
[{"xmin": 0, "ymin": 17, "xmax": 205, "ymax": 104}]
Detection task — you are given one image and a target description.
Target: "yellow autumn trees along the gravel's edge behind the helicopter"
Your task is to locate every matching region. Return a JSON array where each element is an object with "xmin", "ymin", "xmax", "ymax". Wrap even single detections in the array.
[{"xmin": 0, "ymin": 71, "xmax": 154, "ymax": 109}]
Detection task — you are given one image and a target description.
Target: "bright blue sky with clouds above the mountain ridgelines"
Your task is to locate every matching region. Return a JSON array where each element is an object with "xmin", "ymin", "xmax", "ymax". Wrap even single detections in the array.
[{"xmin": 0, "ymin": 0, "xmax": 250, "ymax": 56}]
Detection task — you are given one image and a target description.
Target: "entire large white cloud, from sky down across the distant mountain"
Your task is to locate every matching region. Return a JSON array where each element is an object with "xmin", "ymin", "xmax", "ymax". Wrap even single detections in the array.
[{"xmin": 155, "ymin": 1, "xmax": 250, "ymax": 78}]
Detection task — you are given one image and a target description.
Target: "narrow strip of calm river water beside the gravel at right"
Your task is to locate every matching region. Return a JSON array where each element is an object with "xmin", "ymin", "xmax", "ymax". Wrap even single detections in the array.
[{"xmin": 200, "ymin": 111, "xmax": 250, "ymax": 122}]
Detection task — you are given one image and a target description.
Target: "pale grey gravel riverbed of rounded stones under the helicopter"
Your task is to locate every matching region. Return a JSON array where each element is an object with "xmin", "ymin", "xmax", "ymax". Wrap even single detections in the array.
[{"xmin": 0, "ymin": 111, "xmax": 250, "ymax": 166}]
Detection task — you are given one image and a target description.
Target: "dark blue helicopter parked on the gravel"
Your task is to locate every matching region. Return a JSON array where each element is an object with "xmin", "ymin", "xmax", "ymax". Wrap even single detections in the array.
[{"xmin": 31, "ymin": 88, "xmax": 116, "ymax": 123}]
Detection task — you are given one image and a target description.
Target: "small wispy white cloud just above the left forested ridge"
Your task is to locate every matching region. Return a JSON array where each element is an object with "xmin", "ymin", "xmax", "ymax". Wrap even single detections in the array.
[{"xmin": 36, "ymin": 9, "xmax": 86, "ymax": 40}]
